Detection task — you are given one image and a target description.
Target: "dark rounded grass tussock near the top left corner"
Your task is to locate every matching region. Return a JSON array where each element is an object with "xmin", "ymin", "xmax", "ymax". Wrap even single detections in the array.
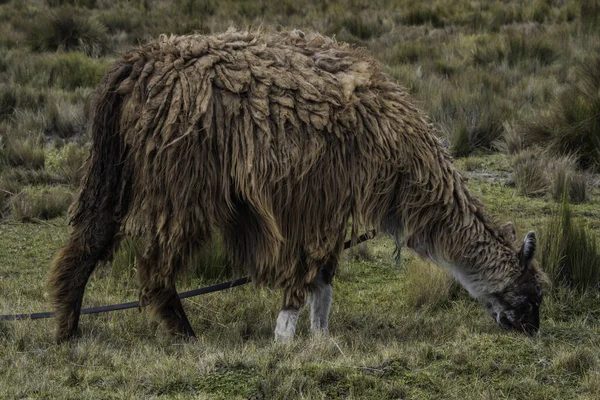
[{"xmin": 27, "ymin": 7, "xmax": 110, "ymax": 57}]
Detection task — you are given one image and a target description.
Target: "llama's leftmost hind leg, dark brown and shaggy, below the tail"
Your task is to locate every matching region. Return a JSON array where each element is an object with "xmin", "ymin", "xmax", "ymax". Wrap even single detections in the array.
[{"xmin": 48, "ymin": 223, "xmax": 117, "ymax": 343}]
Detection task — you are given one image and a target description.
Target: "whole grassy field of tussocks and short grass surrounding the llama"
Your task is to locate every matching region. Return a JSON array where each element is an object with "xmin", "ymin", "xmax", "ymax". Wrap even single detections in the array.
[{"xmin": 0, "ymin": 0, "xmax": 600, "ymax": 399}]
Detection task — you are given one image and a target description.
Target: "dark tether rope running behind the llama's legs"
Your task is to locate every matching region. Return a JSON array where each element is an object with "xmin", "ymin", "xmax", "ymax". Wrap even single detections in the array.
[{"xmin": 0, "ymin": 231, "xmax": 376, "ymax": 321}]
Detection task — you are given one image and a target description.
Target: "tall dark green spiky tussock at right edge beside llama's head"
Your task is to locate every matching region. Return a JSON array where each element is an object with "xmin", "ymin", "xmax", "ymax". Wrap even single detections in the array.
[{"xmin": 540, "ymin": 196, "xmax": 600, "ymax": 291}]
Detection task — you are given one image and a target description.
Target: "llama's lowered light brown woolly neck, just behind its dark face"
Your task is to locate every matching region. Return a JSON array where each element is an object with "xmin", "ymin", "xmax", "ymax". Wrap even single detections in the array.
[{"xmin": 404, "ymin": 168, "xmax": 518, "ymax": 298}]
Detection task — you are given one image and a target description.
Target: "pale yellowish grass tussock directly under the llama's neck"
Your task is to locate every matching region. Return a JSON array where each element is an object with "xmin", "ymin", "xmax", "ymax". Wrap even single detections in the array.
[{"xmin": 403, "ymin": 258, "xmax": 458, "ymax": 310}]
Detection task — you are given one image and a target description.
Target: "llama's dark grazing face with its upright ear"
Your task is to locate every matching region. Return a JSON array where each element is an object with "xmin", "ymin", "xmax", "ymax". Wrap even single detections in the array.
[{"xmin": 481, "ymin": 231, "xmax": 548, "ymax": 335}]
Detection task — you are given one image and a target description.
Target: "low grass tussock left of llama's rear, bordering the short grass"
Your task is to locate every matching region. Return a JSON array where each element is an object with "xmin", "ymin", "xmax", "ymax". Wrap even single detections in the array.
[{"xmin": 11, "ymin": 186, "xmax": 73, "ymax": 222}]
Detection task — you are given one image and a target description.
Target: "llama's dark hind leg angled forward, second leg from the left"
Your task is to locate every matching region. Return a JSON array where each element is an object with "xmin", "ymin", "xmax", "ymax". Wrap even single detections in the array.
[{"xmin": 138, "ymin": 246, "xmax": 196, "ymax": 338}]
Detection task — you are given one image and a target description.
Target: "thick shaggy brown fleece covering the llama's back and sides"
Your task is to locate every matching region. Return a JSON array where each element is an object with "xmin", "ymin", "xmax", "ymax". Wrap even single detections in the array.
[{"xmin": 99, "ymin": 31, "xmax": 443, "ymax": 286}]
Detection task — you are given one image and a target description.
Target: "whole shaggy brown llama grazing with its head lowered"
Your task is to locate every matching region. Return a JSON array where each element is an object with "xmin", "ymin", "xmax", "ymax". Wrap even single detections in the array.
[{"xmin": 49, "ymin": 30, "xmax": 545, "ymax": 341}]
